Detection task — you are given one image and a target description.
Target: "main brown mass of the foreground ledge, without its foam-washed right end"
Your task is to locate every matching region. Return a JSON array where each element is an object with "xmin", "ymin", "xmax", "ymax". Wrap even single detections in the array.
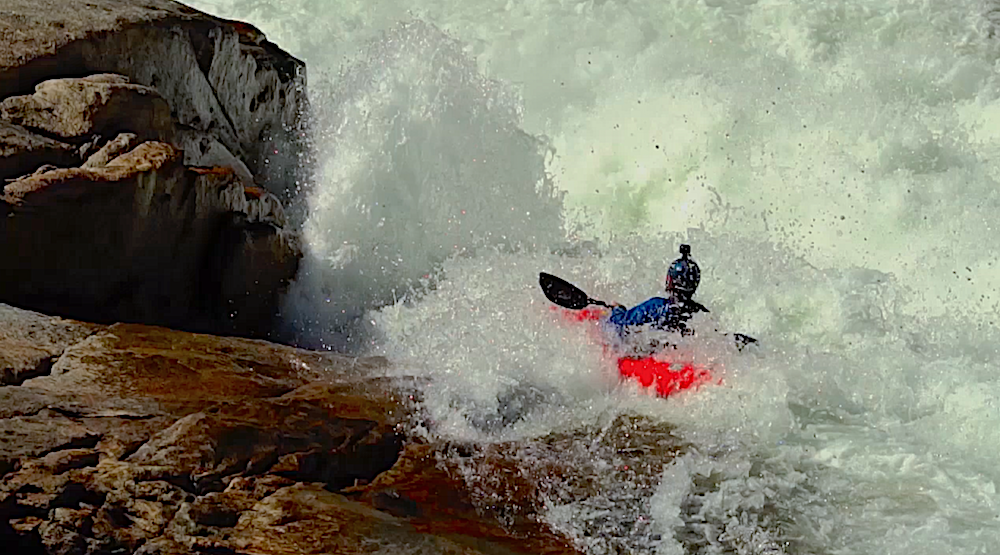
[{"xmin": 0, "ymin": 309, "xmax": 407, "ymax": 553}]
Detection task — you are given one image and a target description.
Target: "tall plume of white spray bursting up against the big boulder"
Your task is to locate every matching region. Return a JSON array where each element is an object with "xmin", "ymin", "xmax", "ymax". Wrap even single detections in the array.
[{"xmin": 278, "ymin": 22, "xmax": 563, "ymax": 350}]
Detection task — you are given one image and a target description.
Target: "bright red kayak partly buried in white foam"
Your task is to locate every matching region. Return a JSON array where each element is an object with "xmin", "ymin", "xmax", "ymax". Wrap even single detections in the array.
[{"xmin": 552, "ymin": 307, "xmax": 712, "ymax": 397}]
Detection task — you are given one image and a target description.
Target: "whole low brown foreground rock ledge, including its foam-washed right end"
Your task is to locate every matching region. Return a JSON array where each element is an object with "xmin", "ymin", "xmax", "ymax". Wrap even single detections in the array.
[{"xmin": 0, "ymin": 307, "xmax": 692, "ymax": 555}]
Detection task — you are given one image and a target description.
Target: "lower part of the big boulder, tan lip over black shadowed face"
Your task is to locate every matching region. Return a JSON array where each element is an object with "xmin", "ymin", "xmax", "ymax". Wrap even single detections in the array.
[{"xmin": 0, "ymin": 132, "xmax": 298, "ymax": 335}]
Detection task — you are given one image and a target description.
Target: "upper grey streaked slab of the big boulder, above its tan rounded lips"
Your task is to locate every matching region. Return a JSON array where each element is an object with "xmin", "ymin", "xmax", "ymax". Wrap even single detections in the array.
[{"xmin": 0, "ymin": 0, "xmax": 306, "ymax": 200}]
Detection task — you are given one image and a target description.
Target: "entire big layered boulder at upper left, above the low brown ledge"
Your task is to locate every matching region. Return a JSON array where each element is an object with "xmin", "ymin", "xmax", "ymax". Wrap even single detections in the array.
[{"xmin": 0, "ymin": 0, "xmax": 306, "ymax": 337}]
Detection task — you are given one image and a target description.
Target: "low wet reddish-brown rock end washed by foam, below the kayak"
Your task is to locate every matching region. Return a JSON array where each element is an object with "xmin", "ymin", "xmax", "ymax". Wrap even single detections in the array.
[{"xmin": 355, "ymin": 416, "xmax": 685, "ymax": 553}]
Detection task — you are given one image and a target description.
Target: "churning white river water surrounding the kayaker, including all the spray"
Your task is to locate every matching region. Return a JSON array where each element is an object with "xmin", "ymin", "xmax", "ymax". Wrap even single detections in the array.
[{"xmin": 189, "ymin": 0, "xmax": 1000, "ymax": 555}]
